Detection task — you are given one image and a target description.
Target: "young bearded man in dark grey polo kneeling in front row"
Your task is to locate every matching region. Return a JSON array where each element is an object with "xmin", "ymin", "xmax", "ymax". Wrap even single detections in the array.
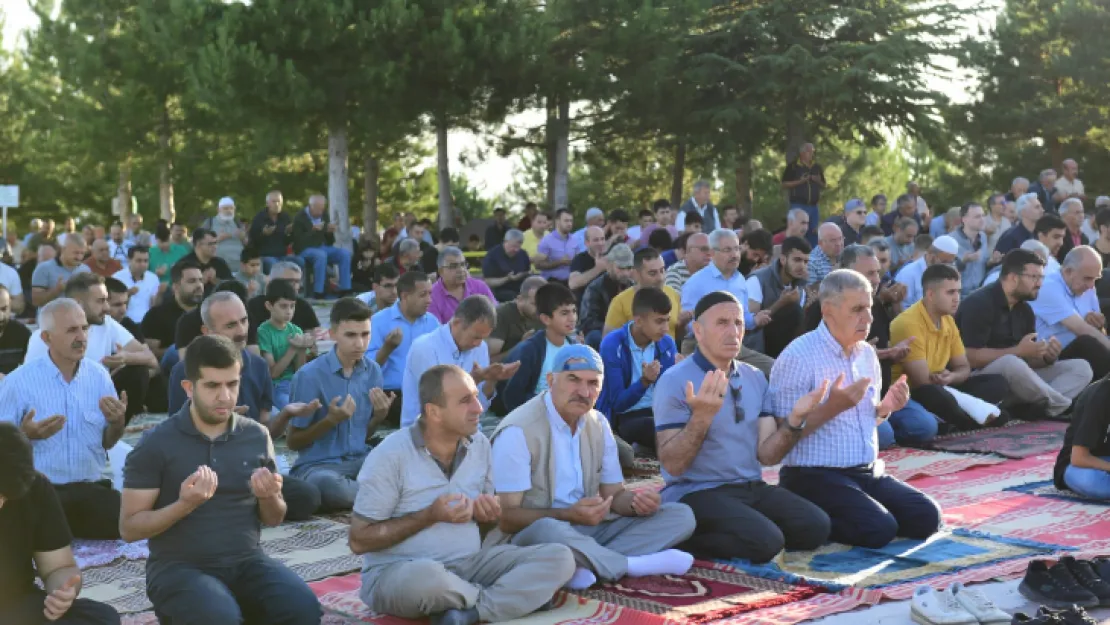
[{"xmin": 120, "ymin": 336, "xmax": 322, "ymax": 625}]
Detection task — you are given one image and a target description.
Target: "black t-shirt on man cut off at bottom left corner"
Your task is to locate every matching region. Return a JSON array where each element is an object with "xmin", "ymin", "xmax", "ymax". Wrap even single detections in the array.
[{"xmin": 0, "ymin": 473, "xmax": 73, "ymax": 614}]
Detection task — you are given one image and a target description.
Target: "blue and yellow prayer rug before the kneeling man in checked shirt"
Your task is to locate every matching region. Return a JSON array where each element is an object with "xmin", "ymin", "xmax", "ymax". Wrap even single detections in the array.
[{"xmin": 739, "ymin": 530, "xmax": 1067, "ymax": 591}]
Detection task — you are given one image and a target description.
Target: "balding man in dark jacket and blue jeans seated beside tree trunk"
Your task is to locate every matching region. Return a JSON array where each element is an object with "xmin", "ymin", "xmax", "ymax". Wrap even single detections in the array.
[{"xmin": 293, "ymin": 195, "xmax": 351, "ymax": 300}]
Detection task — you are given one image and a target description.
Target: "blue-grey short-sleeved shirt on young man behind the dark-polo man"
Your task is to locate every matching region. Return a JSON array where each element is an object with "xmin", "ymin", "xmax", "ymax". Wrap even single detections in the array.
[{"xmin": 290, "ymin": 350, "xmax": 386, "ymax": 471}]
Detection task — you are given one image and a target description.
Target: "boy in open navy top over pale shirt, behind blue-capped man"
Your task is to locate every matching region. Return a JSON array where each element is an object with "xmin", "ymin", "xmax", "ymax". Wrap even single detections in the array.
[{"xmin": 502, "ymin": 282, "xmax": 578, "ymax": 411}]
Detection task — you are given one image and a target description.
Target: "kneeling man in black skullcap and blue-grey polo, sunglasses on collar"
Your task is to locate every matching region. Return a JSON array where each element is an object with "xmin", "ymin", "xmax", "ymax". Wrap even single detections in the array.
[{"xmin": 652, "ymin": 291, "xmax": 829, "ymax": 563}]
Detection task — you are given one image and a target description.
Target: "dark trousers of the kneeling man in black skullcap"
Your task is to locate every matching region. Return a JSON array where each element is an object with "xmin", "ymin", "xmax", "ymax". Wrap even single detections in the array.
[{"xmin": 678, "ymin": 482, "xmax": 829, "ymax": 563}]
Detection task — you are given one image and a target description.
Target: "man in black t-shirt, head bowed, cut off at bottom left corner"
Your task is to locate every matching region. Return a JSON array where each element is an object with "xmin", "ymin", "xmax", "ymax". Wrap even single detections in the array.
[{"xmin": 0, "ymin": 423, "xmax": 121, "ymax": 625}]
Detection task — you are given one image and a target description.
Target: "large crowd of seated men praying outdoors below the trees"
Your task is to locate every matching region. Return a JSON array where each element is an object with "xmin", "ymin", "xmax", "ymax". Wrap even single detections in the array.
[{"xmin": 0, "ymin": 144, "xmax": 1110, "ymax": 625}]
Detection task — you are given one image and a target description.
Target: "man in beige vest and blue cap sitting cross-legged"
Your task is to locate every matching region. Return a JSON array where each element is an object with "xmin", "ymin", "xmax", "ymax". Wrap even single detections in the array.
[{"xmin": 486, "ymin": 344, "xmax": 694, "ymax": 589}]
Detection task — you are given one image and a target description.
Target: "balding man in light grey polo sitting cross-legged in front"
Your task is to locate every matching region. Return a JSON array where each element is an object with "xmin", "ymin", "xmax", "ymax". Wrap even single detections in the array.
[{"xmin": 350, "ymin": 364, "xmax": 574, "ymax": 625}]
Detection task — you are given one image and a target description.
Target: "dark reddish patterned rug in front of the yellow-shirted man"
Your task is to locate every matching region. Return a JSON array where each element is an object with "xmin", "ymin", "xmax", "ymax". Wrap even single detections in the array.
[{"xmin": 929, "ymin": 421, "xmax": 1068, "ymax": 458}]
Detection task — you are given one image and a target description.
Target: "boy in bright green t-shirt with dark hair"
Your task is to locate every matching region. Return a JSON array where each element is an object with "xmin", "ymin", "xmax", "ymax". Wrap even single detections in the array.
[{"xmin": 259, "ymin": 280, "xmax": 313, "ymax": 413}]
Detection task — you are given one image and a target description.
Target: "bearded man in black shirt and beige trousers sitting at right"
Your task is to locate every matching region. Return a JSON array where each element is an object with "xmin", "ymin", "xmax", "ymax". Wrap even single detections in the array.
[{"xmin": 956, "ymin": 249, "xmax": 1092, "ymax": 419}]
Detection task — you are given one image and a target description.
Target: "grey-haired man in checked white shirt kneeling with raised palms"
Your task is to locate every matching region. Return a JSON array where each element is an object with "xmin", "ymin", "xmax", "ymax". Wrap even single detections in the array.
[{"xmin": 764, "ymin": 269, "xmax": 941, "ymax": 547}]
